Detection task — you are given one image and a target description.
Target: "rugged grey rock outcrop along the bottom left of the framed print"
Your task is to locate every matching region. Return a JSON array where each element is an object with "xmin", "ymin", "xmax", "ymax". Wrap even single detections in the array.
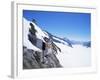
[{"xmin": 23, "ymin": 46, "xmax": 62, "ymax": 69}]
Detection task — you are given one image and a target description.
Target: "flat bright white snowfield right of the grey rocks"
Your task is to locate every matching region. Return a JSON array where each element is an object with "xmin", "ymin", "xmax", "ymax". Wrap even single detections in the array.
[{"xmin": 56, "ymin": 43, "xmax": 91, "ymax": 67}]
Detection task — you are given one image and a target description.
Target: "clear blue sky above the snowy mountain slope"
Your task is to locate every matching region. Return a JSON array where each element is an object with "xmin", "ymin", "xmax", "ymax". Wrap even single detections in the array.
[{"xmin": 23, "ymin": 10, "xmax": 91, "ymax": 41}]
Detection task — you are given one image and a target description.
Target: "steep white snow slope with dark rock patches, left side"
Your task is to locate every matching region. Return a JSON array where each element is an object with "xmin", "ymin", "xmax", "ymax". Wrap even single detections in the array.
[{"xmin": 23, "ymin": 18, "xmax": 60, "ymax": 51}]
